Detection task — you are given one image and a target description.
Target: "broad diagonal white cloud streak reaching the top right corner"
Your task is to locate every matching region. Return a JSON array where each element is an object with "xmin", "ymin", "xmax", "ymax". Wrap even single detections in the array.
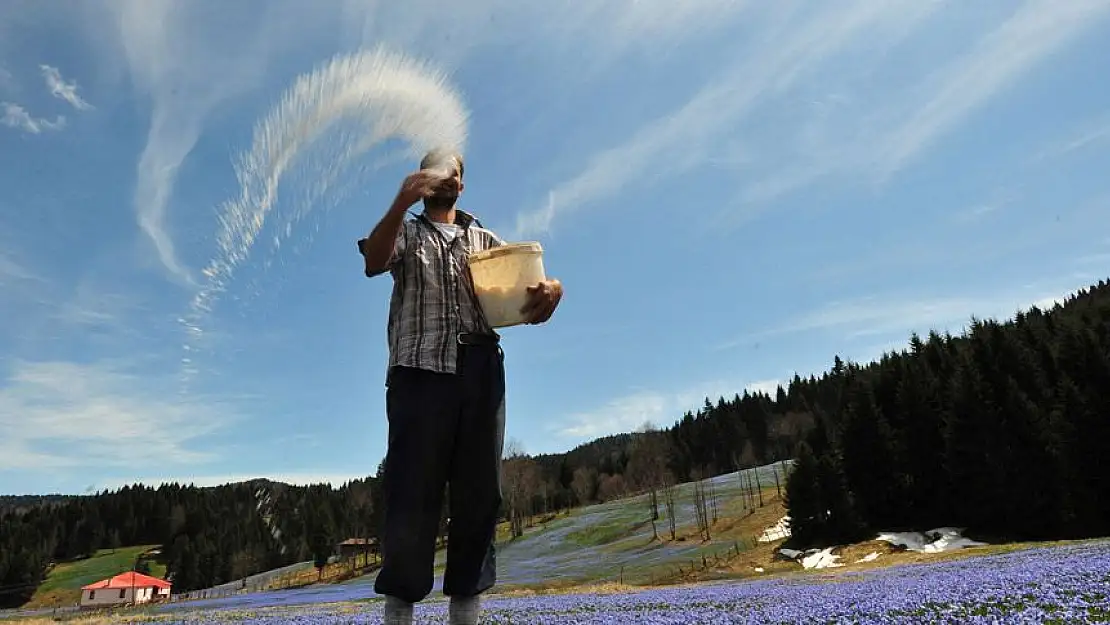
[{"xmin": 729, "ymin": 0, "xmax": 1110, "ymax": 209}]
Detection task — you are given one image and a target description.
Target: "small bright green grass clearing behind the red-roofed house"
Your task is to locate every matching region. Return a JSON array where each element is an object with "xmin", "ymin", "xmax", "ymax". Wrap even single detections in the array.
[{"xmin": 24, "ymin": 545, "xmax": 165, "ymax": 608}]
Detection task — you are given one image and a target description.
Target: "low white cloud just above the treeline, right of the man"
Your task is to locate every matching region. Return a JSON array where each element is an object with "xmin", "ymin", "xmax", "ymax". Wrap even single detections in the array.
[{"xmin": 548, "ymin": 380, "xmax": 784, "ymax": 442}]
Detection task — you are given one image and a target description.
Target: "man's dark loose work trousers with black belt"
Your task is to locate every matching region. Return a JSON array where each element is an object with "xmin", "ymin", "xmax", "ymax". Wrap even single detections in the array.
[{"xmin": 374, "ymin": 345, "xmax": 505, "ymax": 603}]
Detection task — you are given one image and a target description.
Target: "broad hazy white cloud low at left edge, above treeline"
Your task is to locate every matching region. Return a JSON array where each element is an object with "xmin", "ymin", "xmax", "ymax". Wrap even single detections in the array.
[{"xmin": 0, "ymin": 362, "xmax": 236, "ymax": 471}]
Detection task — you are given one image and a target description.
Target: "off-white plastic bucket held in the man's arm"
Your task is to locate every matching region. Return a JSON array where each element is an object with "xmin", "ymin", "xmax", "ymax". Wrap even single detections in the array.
[{"xmin": 470, "ymin": 241, "xmax": 547, "ymax": 327}]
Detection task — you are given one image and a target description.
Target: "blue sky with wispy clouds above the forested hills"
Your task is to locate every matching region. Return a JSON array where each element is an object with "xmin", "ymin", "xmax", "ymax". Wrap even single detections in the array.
[{"xmin": 0, "ymin": 0, "xmax": 1110, "ymax": 493}]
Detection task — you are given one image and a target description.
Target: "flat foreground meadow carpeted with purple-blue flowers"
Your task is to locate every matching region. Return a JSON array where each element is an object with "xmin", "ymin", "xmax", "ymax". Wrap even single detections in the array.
[{"xmin": 129, "ymin": 541, "xmax": 1110, "ymax": 625}]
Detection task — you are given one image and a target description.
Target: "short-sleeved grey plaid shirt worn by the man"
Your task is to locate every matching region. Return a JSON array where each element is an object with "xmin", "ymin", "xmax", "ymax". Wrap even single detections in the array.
[{"xmin": 372, "ymin": 209, "xmax": 505, "ymax": 373}]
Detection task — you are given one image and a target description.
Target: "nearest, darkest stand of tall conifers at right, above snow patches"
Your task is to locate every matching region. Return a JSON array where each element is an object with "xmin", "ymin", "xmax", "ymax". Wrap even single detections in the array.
[{"xmin": 787, "ymin": 281, "xmax": 1110, "ymax": 547}]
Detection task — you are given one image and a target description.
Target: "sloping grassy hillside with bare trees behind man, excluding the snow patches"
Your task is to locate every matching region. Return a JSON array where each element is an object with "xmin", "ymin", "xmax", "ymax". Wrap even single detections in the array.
[{"xmin": 117, "ymin": 463, "xmax": 800, "ymax": 611}]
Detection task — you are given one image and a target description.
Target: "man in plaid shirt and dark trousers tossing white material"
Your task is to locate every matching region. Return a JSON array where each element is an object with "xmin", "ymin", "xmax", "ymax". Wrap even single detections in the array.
[{"xmin": 359, "ymin": 151, "xmax": 563, "ymax": 625}]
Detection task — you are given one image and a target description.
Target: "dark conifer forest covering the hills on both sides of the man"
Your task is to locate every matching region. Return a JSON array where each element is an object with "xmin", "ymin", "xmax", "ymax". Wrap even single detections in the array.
[{"xmin": 0, "ymin": 276, "xmax": 1110, "ymax": 607}]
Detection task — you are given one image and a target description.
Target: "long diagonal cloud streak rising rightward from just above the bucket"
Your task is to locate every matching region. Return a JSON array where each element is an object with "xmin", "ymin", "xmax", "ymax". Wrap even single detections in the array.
[{"xmin": 516, "ymin": 1, "xmax": 935, "ymax": 236}]
